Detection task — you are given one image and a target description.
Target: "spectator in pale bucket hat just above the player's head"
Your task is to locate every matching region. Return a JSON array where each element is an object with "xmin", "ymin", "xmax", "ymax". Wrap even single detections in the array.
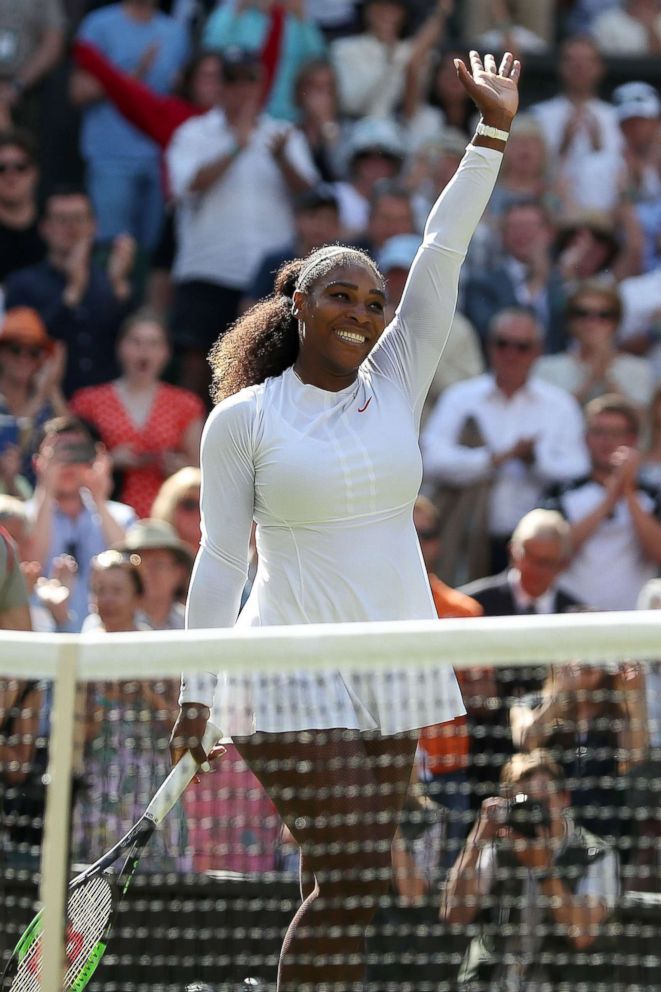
[{"xmin": 335, "ymin": 117, "xmax": 413, "ymax": 238}]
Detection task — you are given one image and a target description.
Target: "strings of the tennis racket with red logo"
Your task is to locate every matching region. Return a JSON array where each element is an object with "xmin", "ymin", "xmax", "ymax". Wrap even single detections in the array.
[{"xmin": 11, "ymin": 875, "xmax": 112, "ymax": 992}]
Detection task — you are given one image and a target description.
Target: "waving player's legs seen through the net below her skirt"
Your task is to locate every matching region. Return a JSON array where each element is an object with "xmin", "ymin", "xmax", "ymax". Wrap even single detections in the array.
[{"xmin": 234, "ymin": 730, "xmax": 417, "ymax": 992}]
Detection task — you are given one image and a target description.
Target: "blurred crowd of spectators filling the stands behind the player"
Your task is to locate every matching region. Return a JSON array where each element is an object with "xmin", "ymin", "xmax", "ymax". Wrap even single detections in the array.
[{"xmin": 0, "ymin": 0, "xmax": 661, "ymax": 987}]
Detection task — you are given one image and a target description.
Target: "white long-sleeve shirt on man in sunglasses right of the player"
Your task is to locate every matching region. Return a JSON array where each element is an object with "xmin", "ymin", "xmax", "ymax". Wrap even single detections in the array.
[{"xmin": 421, "ymin": 372, "xmax": 589, "ymax": 535}]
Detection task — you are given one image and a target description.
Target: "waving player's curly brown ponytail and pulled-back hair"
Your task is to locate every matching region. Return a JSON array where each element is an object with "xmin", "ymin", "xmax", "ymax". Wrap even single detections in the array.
[{"xmin": 209, "ymin": 245, "xmax": 383, "ymax": 403}]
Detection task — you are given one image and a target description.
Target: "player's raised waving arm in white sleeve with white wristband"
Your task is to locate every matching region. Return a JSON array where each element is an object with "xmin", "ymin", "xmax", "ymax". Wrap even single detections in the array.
[{"xmin": 370, "ymin": 51, "xmax": 521, "ymax": 417}]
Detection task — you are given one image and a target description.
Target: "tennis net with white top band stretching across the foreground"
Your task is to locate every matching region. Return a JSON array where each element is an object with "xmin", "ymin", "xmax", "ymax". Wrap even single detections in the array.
[{"xmin": 0, "ymin": 614, "xmax": 661, "ymax": 992}]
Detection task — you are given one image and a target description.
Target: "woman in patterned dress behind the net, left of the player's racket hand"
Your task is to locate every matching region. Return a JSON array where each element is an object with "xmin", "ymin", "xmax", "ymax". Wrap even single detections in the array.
[{"xmin": 72, "ymin": 551, "xmax": 187, "ymax": 873}]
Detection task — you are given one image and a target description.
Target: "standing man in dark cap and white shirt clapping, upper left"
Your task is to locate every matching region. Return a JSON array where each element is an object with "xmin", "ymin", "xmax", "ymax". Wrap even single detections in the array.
[{"xmin": 167, "ymin": 49, "xmax": 317, "ymax": 395}]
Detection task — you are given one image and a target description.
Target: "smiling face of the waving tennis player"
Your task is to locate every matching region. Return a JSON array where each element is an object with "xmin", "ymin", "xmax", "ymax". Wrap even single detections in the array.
[{"xmin": 294, "ymin": 262, "xmax": 386, "ymax": 392}]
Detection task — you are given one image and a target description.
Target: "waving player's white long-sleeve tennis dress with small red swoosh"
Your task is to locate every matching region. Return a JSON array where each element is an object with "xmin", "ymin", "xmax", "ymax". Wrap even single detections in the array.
[{"xmin": 181, "ymin": 146, "xmax": 501, "ymax": 735}]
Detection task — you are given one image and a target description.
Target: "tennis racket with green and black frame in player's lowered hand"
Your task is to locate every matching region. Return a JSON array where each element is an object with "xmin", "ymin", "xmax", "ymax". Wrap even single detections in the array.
[{"xmin": 0, "ymin": 723, "xmax": 222, "ymax": 992}]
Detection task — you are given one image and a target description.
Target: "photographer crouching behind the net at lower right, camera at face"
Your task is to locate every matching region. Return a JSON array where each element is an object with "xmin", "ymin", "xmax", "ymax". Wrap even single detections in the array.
[{"xmin": 442, "ymin": 751, "xmax": 619, "ymax": 992}]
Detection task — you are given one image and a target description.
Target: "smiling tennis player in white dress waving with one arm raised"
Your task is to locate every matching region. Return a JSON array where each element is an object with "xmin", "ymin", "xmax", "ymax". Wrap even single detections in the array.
[{"xmin": 172, "ymin": 52, "xmax": 520, "ymax": 992}]
